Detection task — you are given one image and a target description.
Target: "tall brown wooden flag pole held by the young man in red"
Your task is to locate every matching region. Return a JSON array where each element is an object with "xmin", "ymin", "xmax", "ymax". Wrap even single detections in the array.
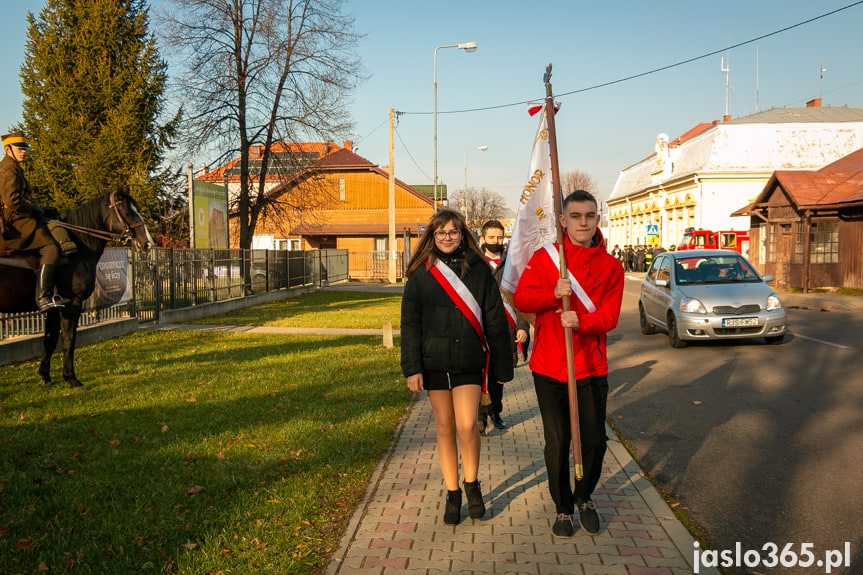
[{"xmin": 543, "ymin": 64, "xmax": 584, "ymax": 481}]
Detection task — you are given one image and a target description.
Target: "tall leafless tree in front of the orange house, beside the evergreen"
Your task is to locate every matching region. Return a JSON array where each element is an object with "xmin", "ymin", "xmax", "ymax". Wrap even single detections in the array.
[{"xmin": 159, "ymin": 0, "xmax": 363, "ymax": 248}]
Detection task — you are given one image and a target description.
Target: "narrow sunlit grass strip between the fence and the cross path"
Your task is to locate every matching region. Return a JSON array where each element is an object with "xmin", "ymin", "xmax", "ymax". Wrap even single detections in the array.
[{"xmin": 191, "ymin": 291, "xmax": 402, "ymax": 329}]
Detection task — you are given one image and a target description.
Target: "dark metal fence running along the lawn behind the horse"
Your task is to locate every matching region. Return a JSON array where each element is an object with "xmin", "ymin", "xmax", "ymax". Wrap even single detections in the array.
[{"xmin": 0, "ymin": 248, "xmax": 349, "ymax": 339}]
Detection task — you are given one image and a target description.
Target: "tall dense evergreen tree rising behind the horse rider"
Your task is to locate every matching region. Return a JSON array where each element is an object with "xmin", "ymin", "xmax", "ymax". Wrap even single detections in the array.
[{"xmin": 21, "ymin": 0, "xmax": 179, "ymax": 219}]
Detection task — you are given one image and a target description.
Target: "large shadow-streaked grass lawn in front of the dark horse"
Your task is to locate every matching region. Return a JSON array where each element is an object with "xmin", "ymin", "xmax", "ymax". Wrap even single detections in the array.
[{"xmin": 0, "ymin": 294, "xmax": 410, "ymax": 575}]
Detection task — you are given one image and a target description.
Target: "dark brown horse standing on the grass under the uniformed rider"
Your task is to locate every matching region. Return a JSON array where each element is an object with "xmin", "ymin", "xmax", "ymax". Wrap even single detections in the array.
[{"xmin": 0, "ymin": 186, "xmax": 154, "ymax": 388}]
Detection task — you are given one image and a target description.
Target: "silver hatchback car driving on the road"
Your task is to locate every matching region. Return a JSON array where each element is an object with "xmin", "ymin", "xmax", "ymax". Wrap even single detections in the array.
[{"xmin": 638, "ymin": 250, "xmax": 786, "ymax": 347}]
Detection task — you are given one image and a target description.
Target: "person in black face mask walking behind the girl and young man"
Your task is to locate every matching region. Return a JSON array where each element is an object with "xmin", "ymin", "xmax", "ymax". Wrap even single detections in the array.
[{"xmin": 478, "ymin": 220, "xmax": 530, "ymax": 434}]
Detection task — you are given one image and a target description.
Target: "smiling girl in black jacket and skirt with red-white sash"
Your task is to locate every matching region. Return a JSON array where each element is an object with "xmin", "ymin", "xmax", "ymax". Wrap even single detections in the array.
[{"xmin": 401, "ymin": 210, "xmax": 513, "ymax": 524}]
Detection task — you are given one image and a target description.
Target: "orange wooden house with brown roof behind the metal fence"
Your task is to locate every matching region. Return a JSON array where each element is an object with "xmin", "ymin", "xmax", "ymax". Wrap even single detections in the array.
[{"xmin": 201, "ymin": 141, "xmax": 434, "ymax": 277}]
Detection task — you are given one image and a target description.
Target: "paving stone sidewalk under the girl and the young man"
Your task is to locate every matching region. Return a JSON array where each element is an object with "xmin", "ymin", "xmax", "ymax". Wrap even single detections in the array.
[{"xmin": 327, "ymin": 365, "xmax": 718, "ymax": 575}]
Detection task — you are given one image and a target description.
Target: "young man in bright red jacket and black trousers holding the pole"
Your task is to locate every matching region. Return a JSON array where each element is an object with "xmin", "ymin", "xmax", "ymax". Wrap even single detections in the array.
[{"xmin": 514, "ymin": 190, "xmax": 623, "ymax": 537}]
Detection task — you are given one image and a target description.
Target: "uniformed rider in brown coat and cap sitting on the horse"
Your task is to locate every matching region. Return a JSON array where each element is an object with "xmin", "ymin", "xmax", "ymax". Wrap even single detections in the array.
[{"xmin": 0, "ymin": 131, "xmax": 69, "ymax": 312}]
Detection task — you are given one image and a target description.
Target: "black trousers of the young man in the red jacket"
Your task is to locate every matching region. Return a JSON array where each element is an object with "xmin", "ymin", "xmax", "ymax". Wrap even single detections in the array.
[{"xmin": 533, "ymin": 373, "xmax": 608, "ymax": 515}]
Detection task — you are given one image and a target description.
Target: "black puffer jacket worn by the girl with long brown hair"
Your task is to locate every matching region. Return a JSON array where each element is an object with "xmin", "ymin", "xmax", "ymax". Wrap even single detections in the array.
[{"xmin": 401, "ymin": 251, "xmax": 513, "ymax": 381}]
